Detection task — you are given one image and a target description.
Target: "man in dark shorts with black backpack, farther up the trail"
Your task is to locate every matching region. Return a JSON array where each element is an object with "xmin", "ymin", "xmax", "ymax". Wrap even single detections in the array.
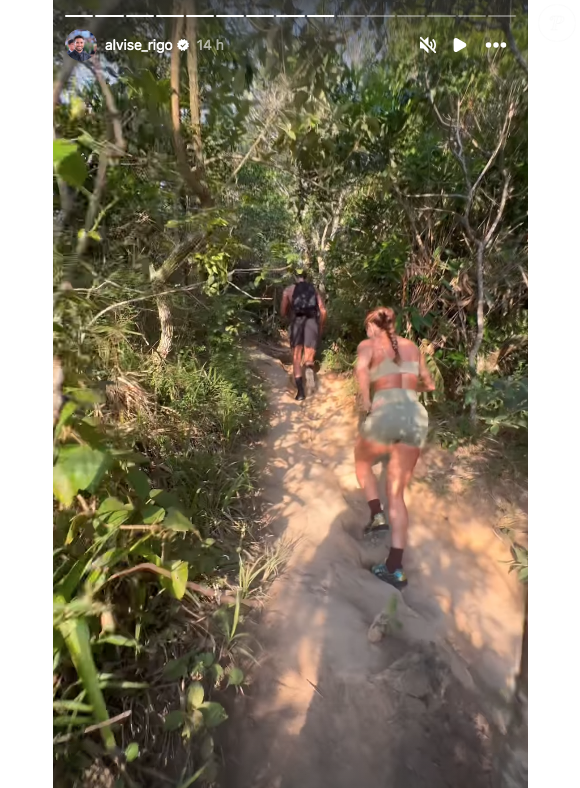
[{"xmin": 280, "ymin": 268, "xmax": 327, "ymax": 401}]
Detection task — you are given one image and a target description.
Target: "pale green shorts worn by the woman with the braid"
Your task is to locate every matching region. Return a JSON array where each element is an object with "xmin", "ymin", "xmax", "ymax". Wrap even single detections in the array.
[{"xmin": 360, "ymin": 389, "xmax": 429, "ymax": 449}]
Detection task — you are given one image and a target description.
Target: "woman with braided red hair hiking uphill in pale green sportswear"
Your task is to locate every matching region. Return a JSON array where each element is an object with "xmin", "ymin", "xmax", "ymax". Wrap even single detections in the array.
[{"xmin": 354, "ymin": 307, "xmax": 435, "ymax": 589}]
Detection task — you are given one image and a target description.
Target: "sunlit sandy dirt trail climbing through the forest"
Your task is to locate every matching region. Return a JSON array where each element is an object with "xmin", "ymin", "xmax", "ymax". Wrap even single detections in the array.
[{"xmin": 224, "ymin": 351, "xmax": 521, "ymax": 788}]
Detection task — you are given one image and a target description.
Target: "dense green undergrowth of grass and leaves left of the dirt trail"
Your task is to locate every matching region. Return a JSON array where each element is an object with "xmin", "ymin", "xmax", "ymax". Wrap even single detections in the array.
[{"xmin": 53, "ymin": 297, "xmax": 278, "ymax": 787}]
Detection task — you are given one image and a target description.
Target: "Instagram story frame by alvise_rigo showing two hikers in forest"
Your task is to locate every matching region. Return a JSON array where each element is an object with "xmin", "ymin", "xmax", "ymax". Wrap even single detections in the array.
[{"xmin": 52, "ymin": 0, "xmax": 528, "ymax": 788}]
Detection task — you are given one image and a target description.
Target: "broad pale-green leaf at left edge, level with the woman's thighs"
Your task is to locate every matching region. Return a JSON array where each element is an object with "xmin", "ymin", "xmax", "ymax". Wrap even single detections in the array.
[{"xmin": 53, "ymin": 446, "xmax": 111, "ymax": 506}]
